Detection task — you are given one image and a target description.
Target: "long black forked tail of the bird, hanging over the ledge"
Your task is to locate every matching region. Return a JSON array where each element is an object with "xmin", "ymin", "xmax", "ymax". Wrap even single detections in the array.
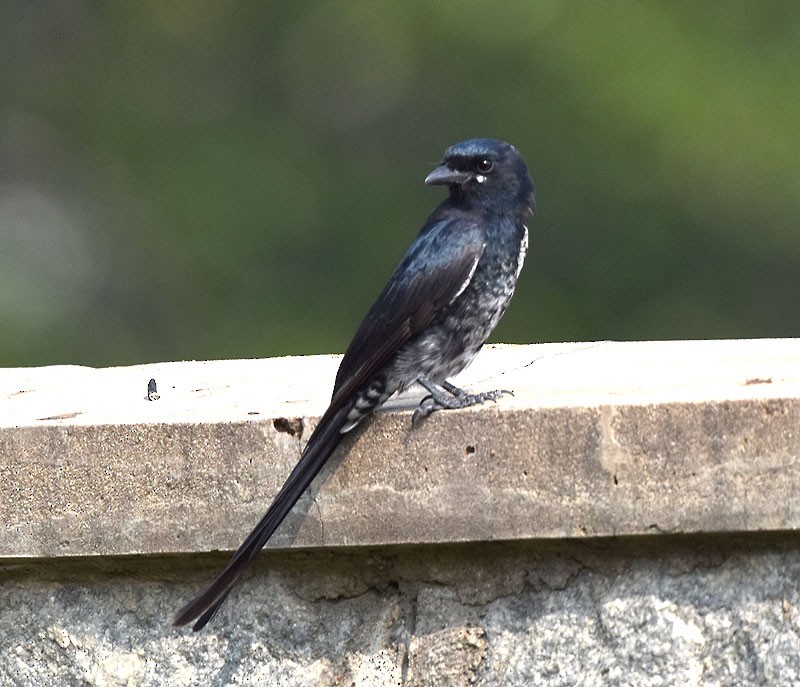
[{"xmin": 172, "ymin": 405, "xmax": 349, "ymax": 632}]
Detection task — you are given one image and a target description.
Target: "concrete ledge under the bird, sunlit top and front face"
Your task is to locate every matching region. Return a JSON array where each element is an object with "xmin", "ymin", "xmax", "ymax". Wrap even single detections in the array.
[{"xmin": 0, "ymin": 340, "xmax": 800, "ymax": 558}]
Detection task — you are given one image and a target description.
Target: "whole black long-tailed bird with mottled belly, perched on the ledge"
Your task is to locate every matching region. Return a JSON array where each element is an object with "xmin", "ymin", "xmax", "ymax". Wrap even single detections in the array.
[{"xmin": 173, "ymin": 138, "xmax": 535, "ymax": 631}]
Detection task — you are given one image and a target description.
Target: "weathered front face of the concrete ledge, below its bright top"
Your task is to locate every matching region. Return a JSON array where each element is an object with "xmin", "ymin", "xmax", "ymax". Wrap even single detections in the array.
[{"xmin": 0, "ymin": 342, "xmax": 800, "ymax": 558}]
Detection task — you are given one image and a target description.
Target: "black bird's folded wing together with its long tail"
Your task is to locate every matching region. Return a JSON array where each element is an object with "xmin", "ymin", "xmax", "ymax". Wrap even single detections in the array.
[{"xmin": 173, "ymin": 219, "xmax": 485, "ymax": 630}]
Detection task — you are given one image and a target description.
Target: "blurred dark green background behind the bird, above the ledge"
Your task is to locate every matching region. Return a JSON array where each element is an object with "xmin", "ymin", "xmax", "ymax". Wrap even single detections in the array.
[{"xmin": 0, "ymin": 0, "xmax": 800, "ymax": 366}]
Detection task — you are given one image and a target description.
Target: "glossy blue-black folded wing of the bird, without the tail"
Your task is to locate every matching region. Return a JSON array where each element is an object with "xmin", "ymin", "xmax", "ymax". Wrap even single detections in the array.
[{"xmin": 330, "ymin": 216, "xmax": 486, "ymax": 410}]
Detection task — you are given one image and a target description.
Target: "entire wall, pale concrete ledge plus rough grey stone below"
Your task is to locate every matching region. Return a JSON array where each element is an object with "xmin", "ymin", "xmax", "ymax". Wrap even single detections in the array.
[{"xmin": 0, "ymin": 340, "xmax": 800, "ymax": 687}]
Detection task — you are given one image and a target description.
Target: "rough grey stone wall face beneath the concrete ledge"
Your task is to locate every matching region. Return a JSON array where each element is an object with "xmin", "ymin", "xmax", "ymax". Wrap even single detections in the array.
[{"xmin": 0, "ymin": 535, "xmax": 800, "ymax": 687}]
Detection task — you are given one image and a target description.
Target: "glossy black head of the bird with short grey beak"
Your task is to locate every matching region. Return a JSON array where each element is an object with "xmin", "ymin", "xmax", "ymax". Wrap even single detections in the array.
[{"xmin": 425, "ymin": 138, "xmax": 534, "ymax": 215}]
